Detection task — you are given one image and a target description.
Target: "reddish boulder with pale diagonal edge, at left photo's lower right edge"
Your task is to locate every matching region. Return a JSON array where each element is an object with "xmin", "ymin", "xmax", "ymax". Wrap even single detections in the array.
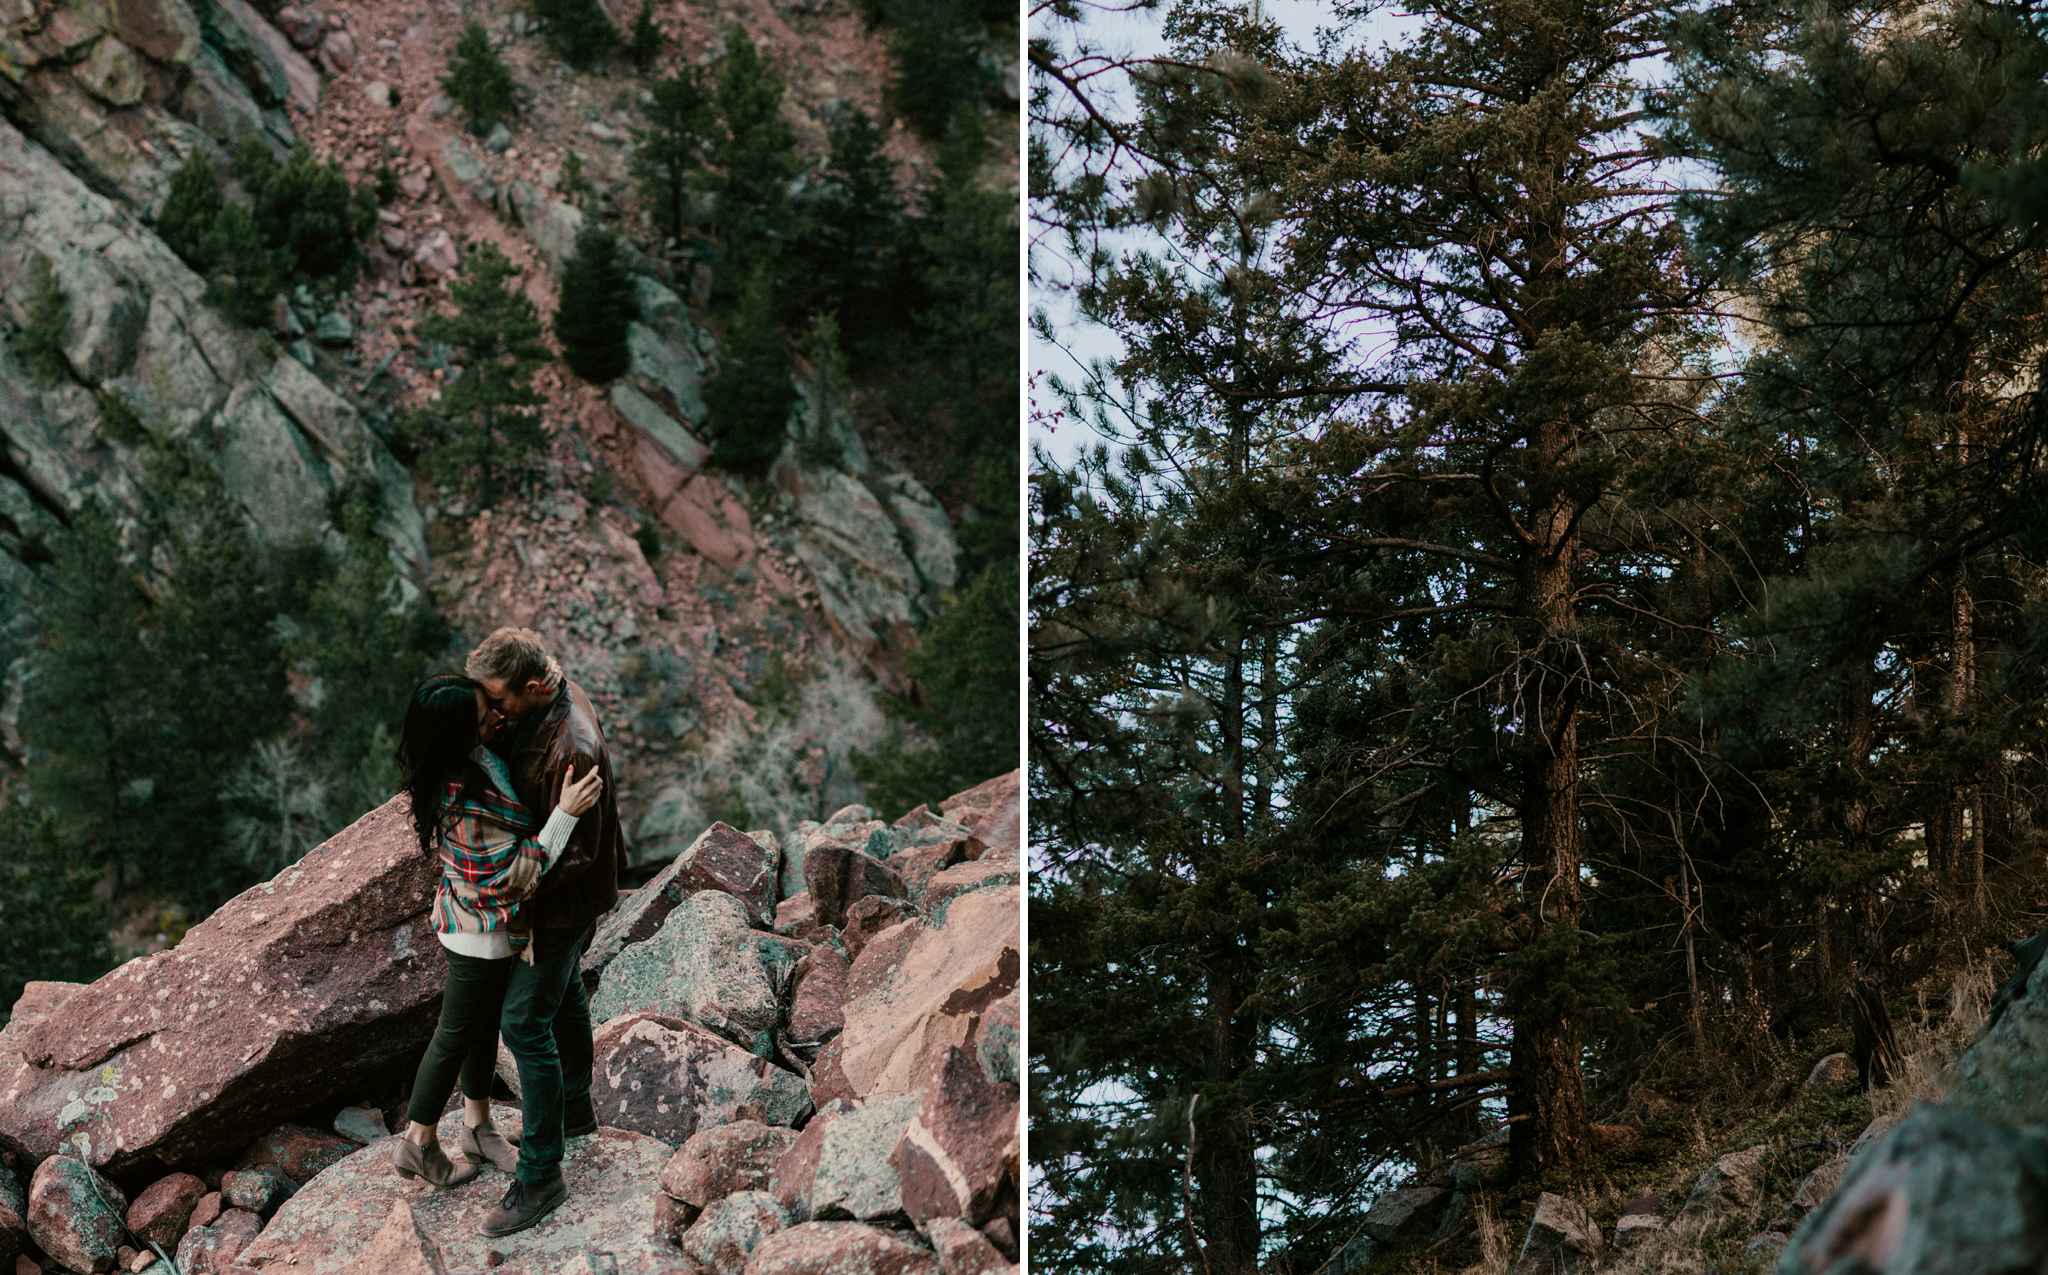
[{"xmin": 889, "ymin": 1046, "xmax": 1018, "ymax": 1226}]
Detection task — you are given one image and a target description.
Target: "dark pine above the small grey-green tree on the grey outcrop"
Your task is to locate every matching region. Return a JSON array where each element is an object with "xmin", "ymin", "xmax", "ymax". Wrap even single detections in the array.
[{"xmin": 809, "ymin": 106, "xmax": 905, "ymax": 327}]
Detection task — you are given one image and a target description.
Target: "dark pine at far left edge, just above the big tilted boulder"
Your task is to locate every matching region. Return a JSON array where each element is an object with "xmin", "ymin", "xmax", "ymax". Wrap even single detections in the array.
[{"xmin": 0, "ymin": 794, "xmax": 115, "ymax": 1025}]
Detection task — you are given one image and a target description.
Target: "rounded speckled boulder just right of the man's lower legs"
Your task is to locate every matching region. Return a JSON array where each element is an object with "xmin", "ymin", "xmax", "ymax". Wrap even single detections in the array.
[{"xmin": 590, "ymin": 1013, "xmax": 811, "ymax": 1146}]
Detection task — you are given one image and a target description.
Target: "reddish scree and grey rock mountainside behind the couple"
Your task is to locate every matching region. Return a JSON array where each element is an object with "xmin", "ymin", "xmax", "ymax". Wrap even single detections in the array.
[{"xmin": 0, "ymin": 0, "xmax": 999, "ymax": 839}]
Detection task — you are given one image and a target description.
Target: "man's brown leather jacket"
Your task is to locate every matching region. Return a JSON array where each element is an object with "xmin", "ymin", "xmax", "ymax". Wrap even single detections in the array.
[{"xmin": 510, "ymin": 677, "xmax": 627, "ymax": 929}]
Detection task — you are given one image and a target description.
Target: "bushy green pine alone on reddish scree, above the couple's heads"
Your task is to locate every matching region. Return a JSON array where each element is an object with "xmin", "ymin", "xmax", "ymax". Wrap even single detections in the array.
[{"xmin": 420, "ymin": 241, "xmax": 549, "ymax": 499}]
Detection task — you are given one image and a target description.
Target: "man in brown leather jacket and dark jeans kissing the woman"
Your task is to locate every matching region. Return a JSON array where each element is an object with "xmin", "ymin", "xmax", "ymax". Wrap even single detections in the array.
[{"xmin": 467, "ymin": 628, "xmax": 625, "ymax": 1236}]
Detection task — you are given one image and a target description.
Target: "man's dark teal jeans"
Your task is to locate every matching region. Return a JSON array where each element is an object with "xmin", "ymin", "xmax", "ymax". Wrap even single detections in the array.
[{"xmin": 498, "ymin": 925, "xmax": 592, "ymax": 1183}]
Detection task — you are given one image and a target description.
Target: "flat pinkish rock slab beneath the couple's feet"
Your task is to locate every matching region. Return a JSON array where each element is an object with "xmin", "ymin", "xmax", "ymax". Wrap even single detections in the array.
[{"xmin": 236, "ymin": 1113, "xmax": 680, "ymax": 1275}]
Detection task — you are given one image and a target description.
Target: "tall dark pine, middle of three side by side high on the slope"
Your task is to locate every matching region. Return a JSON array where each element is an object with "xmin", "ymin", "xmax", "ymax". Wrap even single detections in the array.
[{"xmin": 707, "ymin": 23, "xmax": 799, "ymax": 291}]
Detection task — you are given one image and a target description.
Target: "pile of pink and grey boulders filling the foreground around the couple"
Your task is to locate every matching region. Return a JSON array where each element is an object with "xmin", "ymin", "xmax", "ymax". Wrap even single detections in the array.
[{"xmin": 0, "ymin": 774, "xmax": 1022, "ymax": 1275}]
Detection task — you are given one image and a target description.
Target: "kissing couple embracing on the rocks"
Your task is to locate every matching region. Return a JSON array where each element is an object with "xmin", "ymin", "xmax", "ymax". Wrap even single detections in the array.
[{"xmin": 391, "ymin": 628, "xmax": 625, "ymax": 1236}]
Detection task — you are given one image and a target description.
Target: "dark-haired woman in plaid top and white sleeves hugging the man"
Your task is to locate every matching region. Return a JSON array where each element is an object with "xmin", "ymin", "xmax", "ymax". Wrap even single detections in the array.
[{"xmin": 391, "ymin": 675, "xmax": 604, "ymax": 1187}]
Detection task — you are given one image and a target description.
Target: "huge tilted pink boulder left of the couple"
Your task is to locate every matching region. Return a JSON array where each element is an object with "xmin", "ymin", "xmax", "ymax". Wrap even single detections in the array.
[{"xmin": 0, "ymin": 796, "xmax": 449, "ymax": 1173}]
